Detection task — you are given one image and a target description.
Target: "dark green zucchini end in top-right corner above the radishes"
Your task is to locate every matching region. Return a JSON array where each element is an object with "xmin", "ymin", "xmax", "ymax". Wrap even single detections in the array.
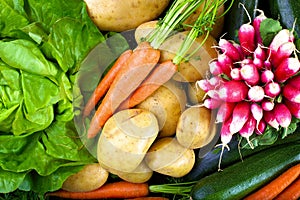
[{"xmin": 269, "ymin": 0, "xmax": 300, "ymax": 38}]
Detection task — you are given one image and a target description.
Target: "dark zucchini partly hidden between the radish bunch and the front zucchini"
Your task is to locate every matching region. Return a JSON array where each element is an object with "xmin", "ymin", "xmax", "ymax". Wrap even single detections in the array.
[{"xmin": 182, "ymin": 133, "xmax": 300, "ymax": 182}]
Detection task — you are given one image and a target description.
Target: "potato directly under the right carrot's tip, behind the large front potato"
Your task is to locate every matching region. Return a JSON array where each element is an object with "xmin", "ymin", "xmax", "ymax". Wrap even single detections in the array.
[{"xmin": 136, "ymin": 80, "xmax": 186, "ymax": 137}]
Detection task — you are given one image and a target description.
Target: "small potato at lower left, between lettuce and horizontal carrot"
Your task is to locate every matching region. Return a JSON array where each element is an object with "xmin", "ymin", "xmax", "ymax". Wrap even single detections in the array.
[{"xmin": 62, "ymin": 163, "xmax": 109, "ymax": 192}]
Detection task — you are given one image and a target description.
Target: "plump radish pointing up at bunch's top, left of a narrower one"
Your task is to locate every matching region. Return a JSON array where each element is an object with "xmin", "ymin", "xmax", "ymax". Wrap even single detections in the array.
[{"xmin": 238, "ymin": 24, "xmax": 255, "ymax": 55}]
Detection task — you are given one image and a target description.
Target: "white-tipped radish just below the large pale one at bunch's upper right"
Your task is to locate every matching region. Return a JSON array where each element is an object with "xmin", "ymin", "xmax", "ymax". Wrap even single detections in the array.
[{"xmin": 271, "ymin": 42, "xmax": 296, "ymax": 68}]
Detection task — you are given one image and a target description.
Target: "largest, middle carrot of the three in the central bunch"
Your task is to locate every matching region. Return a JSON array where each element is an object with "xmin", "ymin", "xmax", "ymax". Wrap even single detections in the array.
[{"xmin": 88, "ymin": 42, "xmax": 160, "ymax": 138}]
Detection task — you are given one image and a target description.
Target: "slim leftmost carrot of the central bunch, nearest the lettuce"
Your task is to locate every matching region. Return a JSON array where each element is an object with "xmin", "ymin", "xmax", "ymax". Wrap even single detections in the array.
[{"xmin": 83, "ymin": 49, "xmax": 132, "ymax": 117}]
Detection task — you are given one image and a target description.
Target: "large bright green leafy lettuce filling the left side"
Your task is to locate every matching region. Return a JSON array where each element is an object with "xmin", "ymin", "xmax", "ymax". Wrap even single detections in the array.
[{"xmin": 0, "ymin": 0, "xmax": 128, "ymax": 198}]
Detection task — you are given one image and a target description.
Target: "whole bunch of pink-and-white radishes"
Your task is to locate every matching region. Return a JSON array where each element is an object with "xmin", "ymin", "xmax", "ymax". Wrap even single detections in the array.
[{"xmin": 197, "ymin": 14, "xmax": 300, "ymax": 146}]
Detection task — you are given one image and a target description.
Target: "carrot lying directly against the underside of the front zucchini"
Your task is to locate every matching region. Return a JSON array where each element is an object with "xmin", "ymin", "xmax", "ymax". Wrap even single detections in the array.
[{"xmin": 245, "ymin": 163, "xmax": 300, "ymax": 200}]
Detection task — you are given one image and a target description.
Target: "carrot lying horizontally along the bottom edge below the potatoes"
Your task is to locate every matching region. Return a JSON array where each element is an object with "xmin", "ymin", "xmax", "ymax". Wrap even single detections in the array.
[{"xmin": 46, "ymin": 181, "xmax": 149, "ymax": 199}]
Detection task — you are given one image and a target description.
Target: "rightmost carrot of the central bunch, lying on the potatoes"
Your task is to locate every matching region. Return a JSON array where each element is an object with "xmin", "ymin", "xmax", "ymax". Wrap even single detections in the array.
[{"xmin": 119, "ymin": 60, "xmax": 177, "ymax": 110}]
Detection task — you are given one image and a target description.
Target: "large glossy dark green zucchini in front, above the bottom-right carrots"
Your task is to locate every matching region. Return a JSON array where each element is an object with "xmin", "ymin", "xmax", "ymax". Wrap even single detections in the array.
[{"xmin": 190, "ymin": 141, "xmax": 300, "ymax": 200}]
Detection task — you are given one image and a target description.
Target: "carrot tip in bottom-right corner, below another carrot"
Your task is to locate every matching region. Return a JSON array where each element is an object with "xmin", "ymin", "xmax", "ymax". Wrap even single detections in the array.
[{"xmin": 274, "ymin": 177, "xmax": 300, "ymax": 200}]
